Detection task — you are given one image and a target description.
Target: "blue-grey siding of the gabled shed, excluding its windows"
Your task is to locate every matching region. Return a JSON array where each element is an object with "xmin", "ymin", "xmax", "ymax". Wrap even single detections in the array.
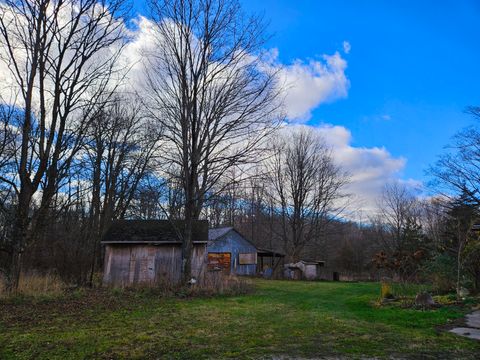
[{"xmin": 207, "ymin": 230, "xmax": 257, "ymax": 276}]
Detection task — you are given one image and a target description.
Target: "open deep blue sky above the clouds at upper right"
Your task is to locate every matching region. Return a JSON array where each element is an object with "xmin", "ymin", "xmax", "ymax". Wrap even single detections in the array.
[{"xmin": 128, "ymin": 0, "xmax": 480, "ymax": 204}]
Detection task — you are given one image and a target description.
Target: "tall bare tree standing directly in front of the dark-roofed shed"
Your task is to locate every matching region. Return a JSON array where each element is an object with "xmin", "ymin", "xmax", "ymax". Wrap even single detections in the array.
[{"xmin": 145, "ymin": 0, "xmax": 279, "ymax": 281}]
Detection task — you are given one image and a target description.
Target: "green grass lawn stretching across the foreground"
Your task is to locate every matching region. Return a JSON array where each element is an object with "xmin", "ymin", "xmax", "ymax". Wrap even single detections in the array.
[{"xmin": 0, "ymin": 280, "xmax": 480, "ymax": 359}]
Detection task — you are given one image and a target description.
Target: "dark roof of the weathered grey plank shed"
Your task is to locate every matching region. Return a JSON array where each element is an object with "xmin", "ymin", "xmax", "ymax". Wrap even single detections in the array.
[{"xmin": 102, "ymin": 220, "xmax": 208, "ymax": 244}]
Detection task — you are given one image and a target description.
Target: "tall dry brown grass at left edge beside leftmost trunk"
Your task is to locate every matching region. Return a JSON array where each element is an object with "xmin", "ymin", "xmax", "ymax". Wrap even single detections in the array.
[{"xmin": 0, "ymin": 273, "xmax": 65, "ymax": 297}]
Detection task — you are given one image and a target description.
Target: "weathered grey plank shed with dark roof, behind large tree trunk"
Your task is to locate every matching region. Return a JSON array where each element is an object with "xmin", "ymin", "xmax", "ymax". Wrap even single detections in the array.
[{"xmin": 102, "ymin": 220, "xmax": 208, "ymax": 286}]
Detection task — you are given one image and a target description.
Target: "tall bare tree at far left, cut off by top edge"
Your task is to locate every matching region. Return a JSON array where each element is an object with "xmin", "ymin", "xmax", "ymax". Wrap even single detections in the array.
[{"xmin": 0, "ymin": 0, "xmax": 124, "ymax": 289}]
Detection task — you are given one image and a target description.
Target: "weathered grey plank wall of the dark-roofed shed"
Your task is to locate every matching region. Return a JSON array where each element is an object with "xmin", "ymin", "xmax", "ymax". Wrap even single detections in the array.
[{"xmin": 103, "ymin": 244, "xmax": 206, "ymax": 286}]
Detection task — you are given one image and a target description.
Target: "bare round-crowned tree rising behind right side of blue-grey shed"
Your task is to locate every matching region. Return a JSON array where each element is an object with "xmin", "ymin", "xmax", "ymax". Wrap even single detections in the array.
[{"xmin": 268, "ymin": 128, "xmax": 348, "ymax": 261}]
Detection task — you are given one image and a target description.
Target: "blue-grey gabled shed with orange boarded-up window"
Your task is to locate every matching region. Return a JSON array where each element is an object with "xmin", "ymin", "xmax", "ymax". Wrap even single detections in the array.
[{"xmin": 207, "ymin": 227, "xmax": 257, "ymax": 276}]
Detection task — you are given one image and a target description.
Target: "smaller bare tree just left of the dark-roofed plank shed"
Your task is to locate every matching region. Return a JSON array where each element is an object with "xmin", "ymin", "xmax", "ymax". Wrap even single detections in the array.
[{"xmin": 80, "ymin": 96, "xmax": 161, "ymax": 283}]
